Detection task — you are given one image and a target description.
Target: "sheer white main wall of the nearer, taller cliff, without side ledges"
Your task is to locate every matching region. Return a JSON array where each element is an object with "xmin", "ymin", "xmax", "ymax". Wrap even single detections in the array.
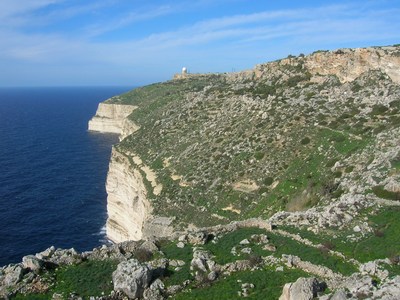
[{"xmin": 106, "ymin": 149, "xmax": 151, "ymax": 243}]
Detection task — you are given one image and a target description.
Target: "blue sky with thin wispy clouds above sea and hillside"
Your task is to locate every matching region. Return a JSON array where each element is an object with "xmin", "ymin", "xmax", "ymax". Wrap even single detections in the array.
[{"xmin": 0, "ymin": 0, "xmax": 400, "ymax": 87}]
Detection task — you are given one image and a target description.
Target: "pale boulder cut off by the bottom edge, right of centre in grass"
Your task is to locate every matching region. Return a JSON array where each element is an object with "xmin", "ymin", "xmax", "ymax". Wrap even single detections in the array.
[{"xmin": 279, "ymin": 277, "xmax": 321, "ymax": 300}]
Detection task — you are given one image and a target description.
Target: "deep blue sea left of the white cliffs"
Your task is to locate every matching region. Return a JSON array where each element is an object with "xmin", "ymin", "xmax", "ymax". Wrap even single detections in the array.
[{"xmin": 0, "ymin": 87, "xmax": 130, "ymax": 266}]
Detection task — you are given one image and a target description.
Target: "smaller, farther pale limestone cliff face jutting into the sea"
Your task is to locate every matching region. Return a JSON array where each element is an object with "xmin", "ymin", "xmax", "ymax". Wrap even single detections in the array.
[{"xmin": 88, "ymin": 103, "xmax": 138, "ymax": 140}]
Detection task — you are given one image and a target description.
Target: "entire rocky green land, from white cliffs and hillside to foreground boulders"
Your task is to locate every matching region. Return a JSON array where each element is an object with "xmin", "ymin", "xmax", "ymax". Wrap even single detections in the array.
[{"xmin": 0, "ymin": 46, "xmax": 400, "ymax": 300}]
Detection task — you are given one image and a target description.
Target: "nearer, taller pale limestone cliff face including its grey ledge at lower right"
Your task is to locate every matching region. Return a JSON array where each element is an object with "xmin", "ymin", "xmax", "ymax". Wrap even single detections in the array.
[{"xmin": 106, "ymin": 147, "xmax": 173, "ymax": 243}]
